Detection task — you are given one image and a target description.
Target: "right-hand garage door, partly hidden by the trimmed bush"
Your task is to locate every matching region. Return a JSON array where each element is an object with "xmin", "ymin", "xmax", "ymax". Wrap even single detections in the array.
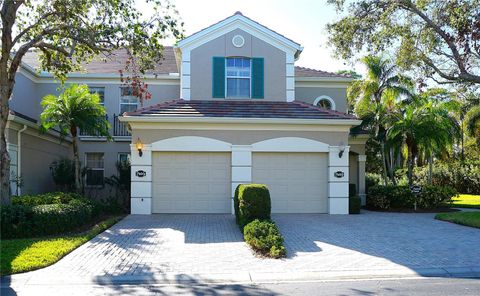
[{"xmin": 252, "ymin": 153, "xmax": 328, "ymax": 213}]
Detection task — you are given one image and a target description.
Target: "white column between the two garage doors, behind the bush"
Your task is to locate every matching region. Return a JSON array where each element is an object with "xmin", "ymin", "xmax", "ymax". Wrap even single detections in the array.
[{"xmin": 231, "ymin": 145, "xmax": 252, "ymax": 214}]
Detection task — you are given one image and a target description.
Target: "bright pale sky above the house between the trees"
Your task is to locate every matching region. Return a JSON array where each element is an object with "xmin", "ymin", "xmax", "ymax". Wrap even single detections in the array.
[{"xmin": 137, "ymin": 0, "xmax": 362, "ymax": 72}]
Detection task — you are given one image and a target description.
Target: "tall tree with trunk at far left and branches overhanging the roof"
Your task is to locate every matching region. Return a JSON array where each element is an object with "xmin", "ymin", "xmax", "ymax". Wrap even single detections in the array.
[{"xmin": 0, "ymin": 0, "xmax": 182, "ymax": 203}]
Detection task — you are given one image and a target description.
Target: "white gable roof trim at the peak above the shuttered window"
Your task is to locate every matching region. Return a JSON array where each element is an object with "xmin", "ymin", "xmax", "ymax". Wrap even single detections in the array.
[{"xmin": 177, "ymin": 11, "xmax": 303, "ymax": 57}]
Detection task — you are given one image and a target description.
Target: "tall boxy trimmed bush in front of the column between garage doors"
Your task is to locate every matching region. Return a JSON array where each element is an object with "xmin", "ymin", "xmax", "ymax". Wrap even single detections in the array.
[{"xmin": 234, "ymin": 184, "xmax": 271, "ymax": 231}]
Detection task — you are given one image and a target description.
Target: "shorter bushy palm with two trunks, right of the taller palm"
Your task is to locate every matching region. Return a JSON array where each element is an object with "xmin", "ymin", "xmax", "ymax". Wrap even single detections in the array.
[{"xmin": 387, "ymin": 90, "xmax": 460, "ymax": 185}]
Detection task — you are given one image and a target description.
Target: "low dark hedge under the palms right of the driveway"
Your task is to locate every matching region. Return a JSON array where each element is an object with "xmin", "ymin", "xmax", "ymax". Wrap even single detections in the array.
[{"xmin": 367, "ymin": 185, "xmax": 457, "ymax": 210}]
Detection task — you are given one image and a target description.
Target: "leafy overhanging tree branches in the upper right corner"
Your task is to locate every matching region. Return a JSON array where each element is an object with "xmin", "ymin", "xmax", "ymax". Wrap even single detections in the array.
[{"xmin": 328, "ymin": 0, "xmax": 480, "ymax": 84}]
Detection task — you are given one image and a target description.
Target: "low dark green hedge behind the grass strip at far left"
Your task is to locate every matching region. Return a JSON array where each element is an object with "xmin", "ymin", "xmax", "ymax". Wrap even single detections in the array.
[{"xmin": 0, "ymin": 199, "xmax": 98, "ymax": 239}]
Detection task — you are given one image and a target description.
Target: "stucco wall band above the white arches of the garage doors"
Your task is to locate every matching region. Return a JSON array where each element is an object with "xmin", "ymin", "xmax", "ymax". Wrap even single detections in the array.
[{"xmin": 132, "ymin": 127, "xmax": 348, "ymax": 145}]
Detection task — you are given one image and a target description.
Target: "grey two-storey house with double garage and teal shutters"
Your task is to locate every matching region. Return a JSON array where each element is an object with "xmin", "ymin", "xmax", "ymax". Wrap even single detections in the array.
[{"xmin": 7, "ymin": 12, "xmax": 366, "ymax": 214}]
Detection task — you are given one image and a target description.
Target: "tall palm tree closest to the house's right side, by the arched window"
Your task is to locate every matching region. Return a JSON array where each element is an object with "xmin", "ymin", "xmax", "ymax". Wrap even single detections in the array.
[{"xmin": 347, "ymin": 55, "xmax": 413, "ymax": 185}]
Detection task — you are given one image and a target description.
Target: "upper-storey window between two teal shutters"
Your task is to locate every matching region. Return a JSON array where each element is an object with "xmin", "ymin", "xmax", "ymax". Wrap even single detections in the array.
[{"xmin": 225, "ymin": 58, "xmax": 251, "ymax": 98}]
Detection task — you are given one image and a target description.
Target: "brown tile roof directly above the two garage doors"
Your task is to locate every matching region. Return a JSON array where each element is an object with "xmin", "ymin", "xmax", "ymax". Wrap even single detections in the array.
[{"xmin": 123, "ymin": 99, "xmax": 356, "ymax": 119}]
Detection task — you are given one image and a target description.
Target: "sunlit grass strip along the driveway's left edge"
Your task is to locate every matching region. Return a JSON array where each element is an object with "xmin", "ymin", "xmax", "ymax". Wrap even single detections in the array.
[{"xmin": 0, "ymin": 216, "xmax": 123, "ymax": 275}]
